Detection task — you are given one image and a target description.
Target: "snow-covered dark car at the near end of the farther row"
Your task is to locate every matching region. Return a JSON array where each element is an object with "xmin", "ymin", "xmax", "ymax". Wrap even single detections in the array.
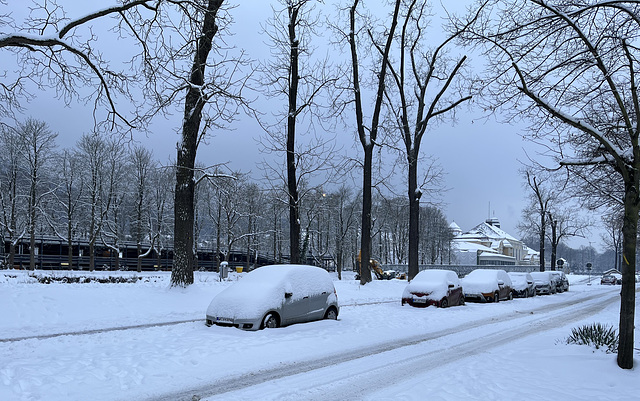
[{"xmin": 402, "ymin": 269, "xmax": 464, "ymax": 308}]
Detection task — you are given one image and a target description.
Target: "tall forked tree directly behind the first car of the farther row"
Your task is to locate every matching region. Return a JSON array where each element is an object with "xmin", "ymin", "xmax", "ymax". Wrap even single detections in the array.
[{"xmin": 377, "ymin": 0, "xmax": 477, "ymax": 280}]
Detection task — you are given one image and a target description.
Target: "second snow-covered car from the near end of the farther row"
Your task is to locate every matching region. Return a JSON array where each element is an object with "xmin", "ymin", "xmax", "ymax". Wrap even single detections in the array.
[{"xmin": 462, "ymin": 269, "xmax": 513, "ymax": 302}]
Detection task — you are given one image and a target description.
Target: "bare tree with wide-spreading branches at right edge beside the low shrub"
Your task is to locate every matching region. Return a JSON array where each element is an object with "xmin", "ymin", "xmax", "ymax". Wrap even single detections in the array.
[{"xmin": 462, "ymin": 0, "xmax": 640, "ymax": 369}]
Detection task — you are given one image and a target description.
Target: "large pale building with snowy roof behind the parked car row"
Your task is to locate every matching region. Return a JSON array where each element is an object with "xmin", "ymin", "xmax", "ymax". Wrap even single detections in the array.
[{"xmin": 449, "ymin": 217, "xmax": 539, "ymax": 265}]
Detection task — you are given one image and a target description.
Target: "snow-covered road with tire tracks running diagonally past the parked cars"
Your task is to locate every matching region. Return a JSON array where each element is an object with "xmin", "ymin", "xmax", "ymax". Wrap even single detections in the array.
[{"xmin": 161, "ymin": 292, "xmax": 619, "ymax": 401}]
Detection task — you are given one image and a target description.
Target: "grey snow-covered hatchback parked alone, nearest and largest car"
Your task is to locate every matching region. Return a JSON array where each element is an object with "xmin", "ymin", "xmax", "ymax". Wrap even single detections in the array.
[{"xmin": 206, "ymin": 265, "xmax": 340, "ymax": 330}]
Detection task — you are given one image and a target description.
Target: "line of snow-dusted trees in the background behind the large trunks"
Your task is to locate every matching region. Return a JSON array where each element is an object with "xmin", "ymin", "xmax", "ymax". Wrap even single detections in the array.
[{"xmin": 0, "ymin": 119, "xmax": 453, "ymax": 276}]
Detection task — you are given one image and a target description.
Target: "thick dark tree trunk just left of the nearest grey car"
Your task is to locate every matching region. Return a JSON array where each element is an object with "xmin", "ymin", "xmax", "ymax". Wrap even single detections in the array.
[{"xmin": 171, "ymin": 0, "xmax": 223, "ymax": 287}]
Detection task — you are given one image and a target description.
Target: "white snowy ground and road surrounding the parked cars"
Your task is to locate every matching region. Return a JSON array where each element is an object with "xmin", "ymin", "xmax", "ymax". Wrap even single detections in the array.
[{"xmin": 0, "ymin": 271, "xmax": 640, "ymax": 400}]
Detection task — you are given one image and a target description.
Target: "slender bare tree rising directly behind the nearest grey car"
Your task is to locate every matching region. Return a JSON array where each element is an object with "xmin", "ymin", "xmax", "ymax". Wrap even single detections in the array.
[{"xmin": 259, "ymin": 0, "xmax": 336, "ymax": 263}]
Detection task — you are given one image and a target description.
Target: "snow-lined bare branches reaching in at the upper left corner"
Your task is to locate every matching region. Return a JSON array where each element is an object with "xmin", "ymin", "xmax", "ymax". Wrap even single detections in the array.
[{"xmin": 0, "ymin": 0, "xmax": 158, "ymax": 128}]
